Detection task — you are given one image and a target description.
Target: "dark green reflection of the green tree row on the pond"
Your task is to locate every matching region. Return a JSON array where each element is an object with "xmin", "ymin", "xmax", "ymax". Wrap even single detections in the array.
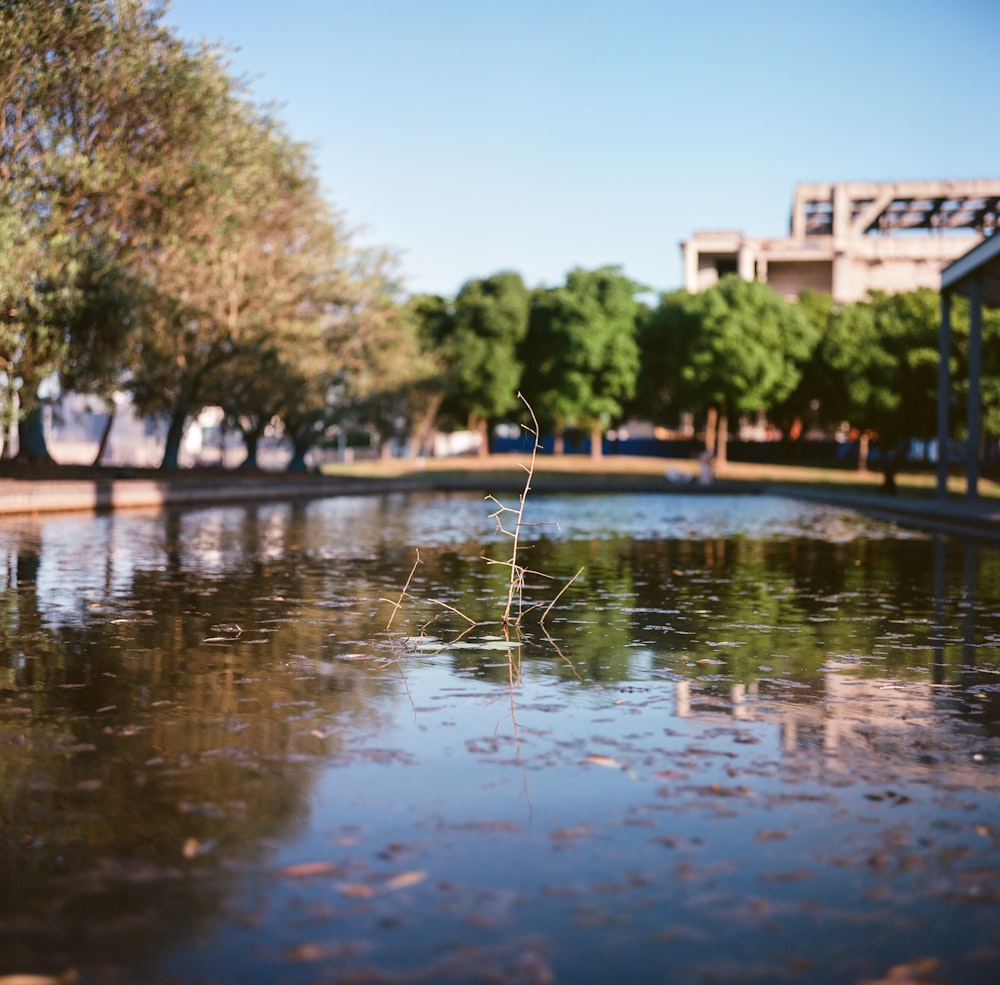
[{"xmin": 470, "ymin": 536, "xmax": 1000, "ymax": 731}]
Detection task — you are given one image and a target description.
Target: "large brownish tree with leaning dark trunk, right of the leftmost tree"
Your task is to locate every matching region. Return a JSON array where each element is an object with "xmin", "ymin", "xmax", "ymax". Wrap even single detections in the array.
[{"xmin": 129, "ymin": 72, "xmax": 344, "ymax": 467}]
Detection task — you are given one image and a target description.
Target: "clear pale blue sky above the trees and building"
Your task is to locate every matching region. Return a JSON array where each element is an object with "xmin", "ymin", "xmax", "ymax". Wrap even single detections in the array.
[{"xmin": 165, "ymin": 0, "xmax": 1000, "ymax": 296}]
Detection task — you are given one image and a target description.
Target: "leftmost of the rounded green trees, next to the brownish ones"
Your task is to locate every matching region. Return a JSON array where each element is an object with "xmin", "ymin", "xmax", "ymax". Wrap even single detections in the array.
[{"xmin": 439, "ymin": 271, "xmax": 530, "ymax": 455}]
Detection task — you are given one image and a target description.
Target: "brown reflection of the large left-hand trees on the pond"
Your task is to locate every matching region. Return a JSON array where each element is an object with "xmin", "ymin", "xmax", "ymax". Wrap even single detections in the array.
[{"xmin": 0, "ymin": 510, "xmax": 397, "ymax": 974}]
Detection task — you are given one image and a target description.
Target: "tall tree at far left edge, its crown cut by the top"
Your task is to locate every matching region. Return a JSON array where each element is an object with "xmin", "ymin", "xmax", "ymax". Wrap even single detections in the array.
[{"xmin": 0, "ymin": 0, "xmax": 209, "ymax": 458}]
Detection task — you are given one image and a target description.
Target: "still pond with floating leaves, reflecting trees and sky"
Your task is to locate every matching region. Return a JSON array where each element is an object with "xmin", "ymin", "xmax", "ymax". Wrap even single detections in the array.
[{"xmin": 0, "ymin": 494, "xmax": 1000, "ymax": 985}]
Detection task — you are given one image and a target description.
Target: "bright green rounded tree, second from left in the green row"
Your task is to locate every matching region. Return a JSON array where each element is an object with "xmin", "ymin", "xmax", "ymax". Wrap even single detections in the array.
[{"xmin": 522, "ymin": 267, "xmax": 643, "ymax": 457}]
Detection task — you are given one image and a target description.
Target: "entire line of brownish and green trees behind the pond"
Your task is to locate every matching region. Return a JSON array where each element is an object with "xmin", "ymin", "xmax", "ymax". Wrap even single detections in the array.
[{"xmin": 0, "ymin": 0, "xmax": 1000, "ymax": 468}]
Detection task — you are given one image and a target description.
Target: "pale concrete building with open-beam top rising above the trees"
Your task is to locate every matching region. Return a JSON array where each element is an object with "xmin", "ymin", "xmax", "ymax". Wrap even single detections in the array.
[{"xmin": 681, "ymin": 179, "xmax": 1000, "ymax": 302}]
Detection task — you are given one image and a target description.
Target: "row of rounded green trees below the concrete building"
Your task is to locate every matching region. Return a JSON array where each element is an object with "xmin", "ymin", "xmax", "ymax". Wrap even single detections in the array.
[{"xmin": 405, "ymin": 267, "xmax": 1000, "ymax": 464}]
